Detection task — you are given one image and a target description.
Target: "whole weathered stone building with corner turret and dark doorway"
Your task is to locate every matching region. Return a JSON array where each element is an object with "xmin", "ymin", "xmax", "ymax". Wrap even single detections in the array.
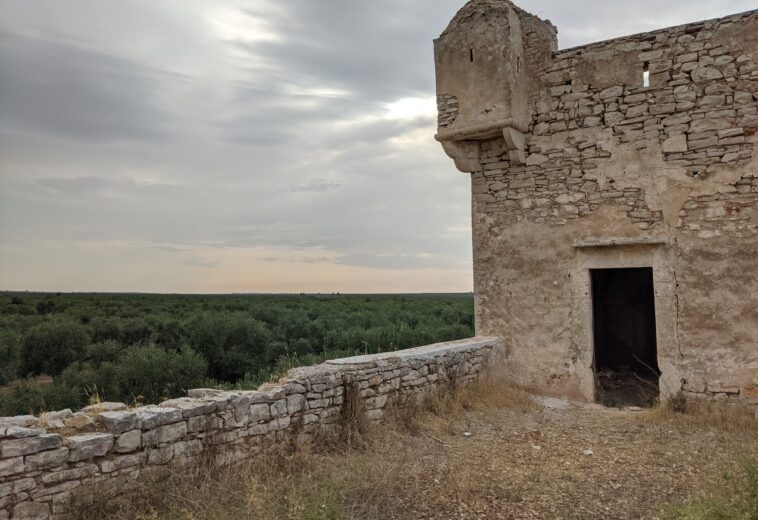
[{"xmin": 435, "ymin": 0, "xmax": 758, "ymax": 404}]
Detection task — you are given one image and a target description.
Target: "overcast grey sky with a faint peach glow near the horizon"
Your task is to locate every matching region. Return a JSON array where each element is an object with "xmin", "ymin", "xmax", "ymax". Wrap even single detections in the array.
[{"xmin": 0, "ymin": 0, "xmax": 757, "ymax": 292}]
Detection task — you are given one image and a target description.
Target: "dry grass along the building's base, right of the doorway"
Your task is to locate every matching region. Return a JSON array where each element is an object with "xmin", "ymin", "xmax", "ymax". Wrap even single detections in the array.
[{"xmin": 640, "ymin": 394, "xmax": 758, "ymax": 435}]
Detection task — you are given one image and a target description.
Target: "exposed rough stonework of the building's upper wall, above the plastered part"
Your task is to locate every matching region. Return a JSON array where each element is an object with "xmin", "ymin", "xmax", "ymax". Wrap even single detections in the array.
[{"xmin": 473, "ymin": 11, "xmax": 758, "ymax": 231}]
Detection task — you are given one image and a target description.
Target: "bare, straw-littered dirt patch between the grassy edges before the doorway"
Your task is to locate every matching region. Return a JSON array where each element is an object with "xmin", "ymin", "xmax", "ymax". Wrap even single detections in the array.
[{"xmin": 377, "ymin": 399, "xmax": 758, "ymax": 520}]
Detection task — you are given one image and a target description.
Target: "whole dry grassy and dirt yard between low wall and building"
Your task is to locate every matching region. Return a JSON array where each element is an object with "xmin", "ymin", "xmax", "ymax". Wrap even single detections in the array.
[{"xmin": 84, "ymin": 381, "xmax": 758, "ymax": 520}]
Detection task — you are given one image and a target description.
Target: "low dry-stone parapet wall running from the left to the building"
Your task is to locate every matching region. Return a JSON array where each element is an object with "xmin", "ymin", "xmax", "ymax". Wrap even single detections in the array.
[{"xmin": 0, "ymin": 337, "xmax": 502, "ymax": 520}]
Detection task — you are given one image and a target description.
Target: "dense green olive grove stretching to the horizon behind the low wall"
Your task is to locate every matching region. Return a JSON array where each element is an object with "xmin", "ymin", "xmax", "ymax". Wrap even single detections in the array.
[{"xmin": 0, "ymin": 293, "xmax": 474, "ymax": 416}]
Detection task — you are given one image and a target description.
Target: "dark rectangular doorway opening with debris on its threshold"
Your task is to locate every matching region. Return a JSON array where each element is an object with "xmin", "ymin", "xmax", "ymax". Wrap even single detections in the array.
[{"xmin": 590, "ymin": 267, "xmax": 660, "ymax": 406}]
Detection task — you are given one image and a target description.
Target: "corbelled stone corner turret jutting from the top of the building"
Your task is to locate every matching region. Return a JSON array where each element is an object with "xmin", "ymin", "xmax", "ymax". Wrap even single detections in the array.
[{"xmin": 434, "ymin": 0, "xmax": 557, "ymax": 172}]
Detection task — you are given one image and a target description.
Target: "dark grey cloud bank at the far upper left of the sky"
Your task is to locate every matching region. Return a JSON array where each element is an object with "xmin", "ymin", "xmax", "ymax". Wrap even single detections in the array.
[{"xmin": 0, "ymin": 34, "xmax": 170, "ymax": 142}]
